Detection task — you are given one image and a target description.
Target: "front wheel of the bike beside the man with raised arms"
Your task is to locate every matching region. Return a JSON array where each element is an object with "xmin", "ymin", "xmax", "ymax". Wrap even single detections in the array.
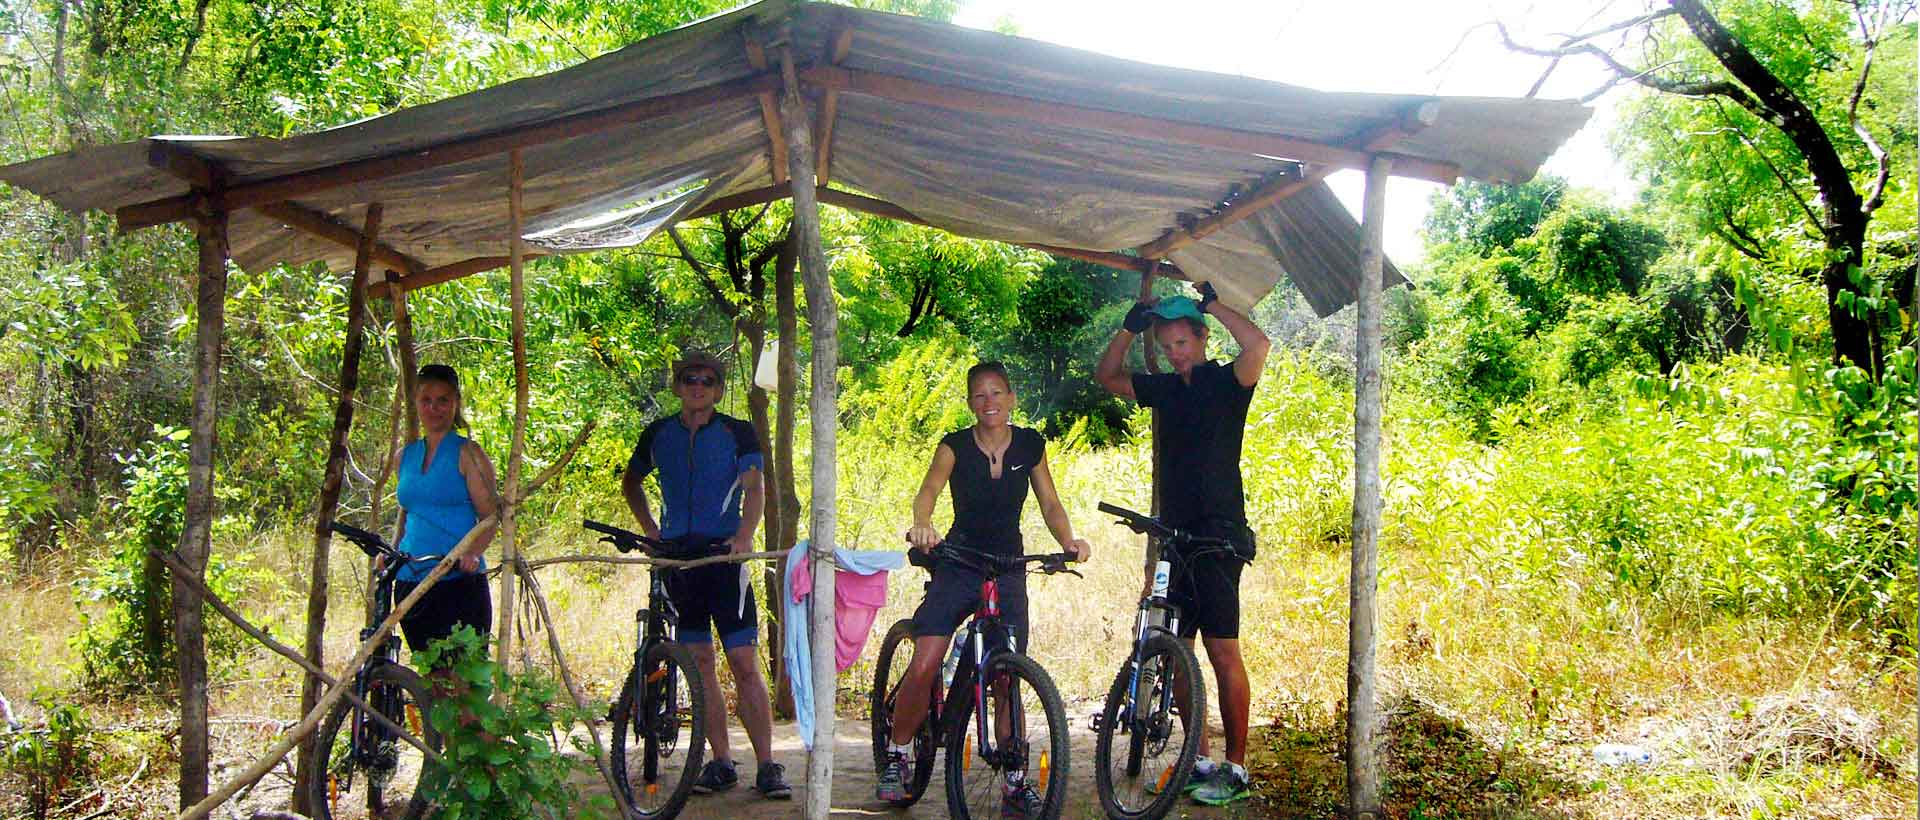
[{"xmin": 1092, "ymin": 634, "xmax": 1206, "ymax": 820}]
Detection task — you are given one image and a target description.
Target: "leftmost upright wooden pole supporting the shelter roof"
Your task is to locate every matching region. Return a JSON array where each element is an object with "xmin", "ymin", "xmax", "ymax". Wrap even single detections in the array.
[{"xmin": 173, "ymin": 203, "xmax": 227, "ymax": 808}]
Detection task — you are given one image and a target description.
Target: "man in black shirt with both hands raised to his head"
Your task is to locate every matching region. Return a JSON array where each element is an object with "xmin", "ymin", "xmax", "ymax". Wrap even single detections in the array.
[{"xmin": 1094, "ymin": 282, "xmax": 1269, "ymax": 805}]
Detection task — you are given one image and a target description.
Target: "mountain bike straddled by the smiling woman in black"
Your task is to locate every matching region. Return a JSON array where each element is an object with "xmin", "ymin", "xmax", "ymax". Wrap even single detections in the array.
[{"xmin": 870, "ymin": 542, "xmax": 1079, "ymax": 820}]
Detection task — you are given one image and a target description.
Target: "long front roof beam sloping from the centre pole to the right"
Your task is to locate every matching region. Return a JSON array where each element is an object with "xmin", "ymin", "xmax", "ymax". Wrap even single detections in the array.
[{"xmin": 801, "ymin": 65, "xmax": 1459, "ymax": 184}]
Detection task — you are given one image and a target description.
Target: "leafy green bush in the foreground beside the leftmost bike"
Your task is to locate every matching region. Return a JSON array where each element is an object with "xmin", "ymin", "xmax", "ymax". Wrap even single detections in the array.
[{"xmin": 413, "ymin": 626, "xmax": 612, "ymax": 820}]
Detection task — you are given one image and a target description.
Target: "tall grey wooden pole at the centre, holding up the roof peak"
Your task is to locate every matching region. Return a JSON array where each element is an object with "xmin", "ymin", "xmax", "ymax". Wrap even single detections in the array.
[{"xmin": 780, "ymin": 46, "xmax": 839, "ymax": 820}]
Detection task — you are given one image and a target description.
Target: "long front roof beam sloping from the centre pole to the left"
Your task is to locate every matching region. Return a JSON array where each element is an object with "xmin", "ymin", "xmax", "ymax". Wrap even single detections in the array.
[{"xmin": 115, "ymin": 73, "xmax": 780, "ymax": 230}]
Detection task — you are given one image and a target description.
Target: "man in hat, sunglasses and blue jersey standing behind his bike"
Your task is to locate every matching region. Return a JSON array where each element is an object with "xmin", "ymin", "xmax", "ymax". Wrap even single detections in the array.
[{"xmin": 620, "ymin": 351, "xmax": 793, "ymax": 799}]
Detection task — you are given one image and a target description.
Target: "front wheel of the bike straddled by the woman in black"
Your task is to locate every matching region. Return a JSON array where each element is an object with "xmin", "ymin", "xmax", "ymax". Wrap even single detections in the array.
[{"xmin": 947, "ymin": 653, "xmax": 1069, "ymax": 820}]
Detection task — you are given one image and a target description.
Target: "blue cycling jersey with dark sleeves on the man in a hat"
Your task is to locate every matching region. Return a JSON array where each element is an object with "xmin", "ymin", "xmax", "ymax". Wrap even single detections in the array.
[{"xmin": 626, "ymin": 413, "xmax": 764, "ymax": 540}]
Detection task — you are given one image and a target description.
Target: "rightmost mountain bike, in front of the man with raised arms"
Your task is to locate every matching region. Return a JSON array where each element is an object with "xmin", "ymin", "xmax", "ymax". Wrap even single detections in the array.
[{"xmin": 1092, "ymin": 501, "xmax": 1240, "ymax": 820}]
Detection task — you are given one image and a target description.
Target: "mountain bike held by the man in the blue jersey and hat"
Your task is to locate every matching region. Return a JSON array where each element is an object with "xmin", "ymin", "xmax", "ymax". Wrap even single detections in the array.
[{"xmin": 580, "ymin": 520, "xmax": 726, "ymax": 818}]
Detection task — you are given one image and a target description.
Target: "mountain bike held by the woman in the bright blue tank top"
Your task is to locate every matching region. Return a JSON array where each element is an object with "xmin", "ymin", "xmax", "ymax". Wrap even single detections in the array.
[{"xmin": 307, "ymin": 520, "xmax": 442, "ymax": 820}]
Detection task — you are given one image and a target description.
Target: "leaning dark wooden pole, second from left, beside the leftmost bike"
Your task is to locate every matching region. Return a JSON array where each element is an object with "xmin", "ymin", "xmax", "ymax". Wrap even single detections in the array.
[{"xmin": 294, "ymin": 202, "xmax": 384, "ymax": 814}]
